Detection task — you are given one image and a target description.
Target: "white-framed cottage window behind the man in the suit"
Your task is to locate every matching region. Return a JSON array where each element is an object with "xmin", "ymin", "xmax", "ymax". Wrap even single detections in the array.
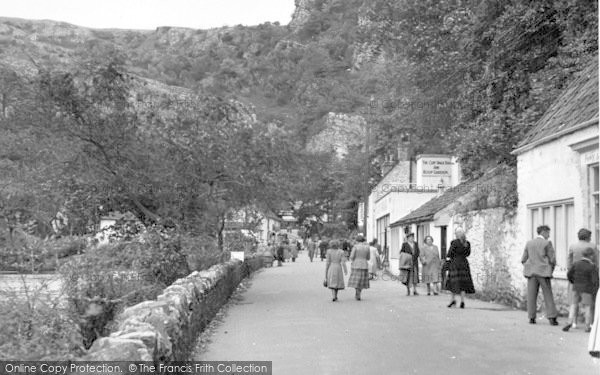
[{"xmin": 527, "ymin": 199, "xmax": 577, "ymax": 276}]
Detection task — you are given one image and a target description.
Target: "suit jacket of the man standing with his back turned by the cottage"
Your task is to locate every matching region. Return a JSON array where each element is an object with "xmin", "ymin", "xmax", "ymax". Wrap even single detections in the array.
[{"xmin": 521, "ymin": 236, "xmax": 556, "ymax": 277}]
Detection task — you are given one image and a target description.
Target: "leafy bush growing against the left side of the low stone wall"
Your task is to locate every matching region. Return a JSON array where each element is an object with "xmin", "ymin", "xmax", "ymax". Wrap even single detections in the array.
[{"xmin": 61, "ymin": 230, "xmax": 190, "ymax": 348}]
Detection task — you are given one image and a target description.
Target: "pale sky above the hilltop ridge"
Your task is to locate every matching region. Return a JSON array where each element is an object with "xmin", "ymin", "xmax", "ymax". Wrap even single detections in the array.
[{"xmin": 0, "ymin": 0, "xmax": 294, "ymax": 30}]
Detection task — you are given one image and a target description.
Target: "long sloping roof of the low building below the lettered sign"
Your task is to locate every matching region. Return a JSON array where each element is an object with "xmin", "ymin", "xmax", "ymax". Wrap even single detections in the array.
[{"xmin": 390, "ymin": 167, "xmax": 501, "ymax": 227}]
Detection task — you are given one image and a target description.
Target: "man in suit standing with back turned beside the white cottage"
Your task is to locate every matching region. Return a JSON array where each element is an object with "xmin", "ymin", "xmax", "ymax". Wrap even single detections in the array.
[{"xmin": 521, "ymin": 225, "xmax": 558, "ymax": 326}]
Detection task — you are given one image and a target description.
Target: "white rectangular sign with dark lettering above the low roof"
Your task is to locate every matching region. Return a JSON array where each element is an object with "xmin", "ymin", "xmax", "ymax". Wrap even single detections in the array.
[{"xmin": 417, "ymin": 155, "xmax": 455, "ymax": 188}]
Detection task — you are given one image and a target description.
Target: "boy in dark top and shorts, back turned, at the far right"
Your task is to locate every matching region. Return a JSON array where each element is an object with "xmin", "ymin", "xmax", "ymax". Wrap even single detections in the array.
[{"xmin": 563, "ymin": 248, "xmax": 599, "ymax": 332}]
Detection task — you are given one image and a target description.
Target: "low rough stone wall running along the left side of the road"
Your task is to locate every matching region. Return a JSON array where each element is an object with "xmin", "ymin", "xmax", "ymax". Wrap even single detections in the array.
[{"xmin": 84, "ymin": 257, "xmax": 262, "ymax": 363}]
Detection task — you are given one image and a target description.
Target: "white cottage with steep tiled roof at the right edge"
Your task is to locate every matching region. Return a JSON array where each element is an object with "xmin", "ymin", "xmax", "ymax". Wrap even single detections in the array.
[{"xmin": 513, "ymin": 59, "xmax": 600, "ymax": 279}]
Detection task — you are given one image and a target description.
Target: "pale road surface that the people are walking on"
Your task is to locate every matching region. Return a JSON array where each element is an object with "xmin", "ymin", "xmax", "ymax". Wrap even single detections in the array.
[{"xmin": 194, "ymin": 251, "xmax": 600, "ymax": 375}]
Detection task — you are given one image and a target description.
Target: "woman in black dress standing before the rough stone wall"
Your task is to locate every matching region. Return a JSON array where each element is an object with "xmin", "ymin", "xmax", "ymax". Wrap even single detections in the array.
[{"xmin": 446, "ymin": 228, "xmax": 475, "ymax": 309}]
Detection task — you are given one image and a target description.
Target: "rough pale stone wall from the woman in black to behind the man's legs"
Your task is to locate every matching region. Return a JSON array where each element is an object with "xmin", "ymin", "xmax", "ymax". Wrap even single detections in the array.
[{"xmin": 454, "ymin": 208, "xmax": 568, "ymax": 314}]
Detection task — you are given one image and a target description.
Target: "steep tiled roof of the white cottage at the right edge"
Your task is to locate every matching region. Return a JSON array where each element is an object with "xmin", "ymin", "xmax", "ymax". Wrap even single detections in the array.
[{"xmin": 513, "ymin": 58, "xmax": 598, "ymax": 154}]
